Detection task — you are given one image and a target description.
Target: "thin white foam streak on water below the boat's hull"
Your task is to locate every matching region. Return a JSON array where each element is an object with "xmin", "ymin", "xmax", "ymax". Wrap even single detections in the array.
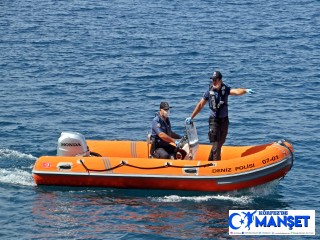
[{"xmin": 152, "ymin": 195, "xmax": 253, "ymax": 204}]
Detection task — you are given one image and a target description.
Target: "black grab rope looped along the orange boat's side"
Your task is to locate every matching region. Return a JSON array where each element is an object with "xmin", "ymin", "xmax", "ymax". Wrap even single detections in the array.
[{"xmin": 80, "ymin": 159, "xmax": 214, "ymax": 172}]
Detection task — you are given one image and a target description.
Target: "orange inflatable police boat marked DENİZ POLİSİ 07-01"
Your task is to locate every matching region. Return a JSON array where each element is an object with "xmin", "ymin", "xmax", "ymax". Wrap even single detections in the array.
[{"xmin": 32, "ymin": 126, "xmax": 294, "ymax": 192}]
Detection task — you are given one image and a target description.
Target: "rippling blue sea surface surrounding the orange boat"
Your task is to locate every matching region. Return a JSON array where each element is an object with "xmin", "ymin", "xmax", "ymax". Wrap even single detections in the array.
[{"xmin": 0, "ymin": 0, "xmax": 320, "ymax": 239}]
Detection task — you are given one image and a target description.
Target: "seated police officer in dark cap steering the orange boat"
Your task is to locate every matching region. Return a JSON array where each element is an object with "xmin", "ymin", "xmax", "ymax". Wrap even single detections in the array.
[{"xmin": 150, "ymin": 102, "xmax": 181, "ymax": 159}]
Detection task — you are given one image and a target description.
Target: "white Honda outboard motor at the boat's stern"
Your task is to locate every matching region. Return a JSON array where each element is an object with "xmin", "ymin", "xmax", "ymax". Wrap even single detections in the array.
[{"xmin": 57, "ymin": 132, "xmax": 90, "ymax": 157}]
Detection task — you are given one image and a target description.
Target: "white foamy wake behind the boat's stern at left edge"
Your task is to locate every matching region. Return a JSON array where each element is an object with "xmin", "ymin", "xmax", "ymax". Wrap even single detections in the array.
[{"xmin": 0, "ymin": 169, "xmax": 35, "ymax": 186}]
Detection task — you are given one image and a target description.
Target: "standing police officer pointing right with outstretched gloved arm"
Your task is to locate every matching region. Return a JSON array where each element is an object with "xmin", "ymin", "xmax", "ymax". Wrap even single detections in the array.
[{"xmin": 185, "ymin": 71, "xmax": 253, "ymax": 161}]
